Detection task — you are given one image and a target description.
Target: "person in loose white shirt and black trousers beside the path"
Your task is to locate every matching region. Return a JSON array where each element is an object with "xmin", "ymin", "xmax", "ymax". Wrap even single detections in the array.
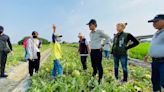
[{"xmin": 27, "ymin": 31, "xmax": 41, "ymax": 76}]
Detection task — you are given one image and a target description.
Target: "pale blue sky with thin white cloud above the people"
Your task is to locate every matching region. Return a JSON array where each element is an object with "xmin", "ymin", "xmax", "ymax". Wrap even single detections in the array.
[{"xmin": 0, "ymin": 0, "xmax": 164, "ymax": 43}]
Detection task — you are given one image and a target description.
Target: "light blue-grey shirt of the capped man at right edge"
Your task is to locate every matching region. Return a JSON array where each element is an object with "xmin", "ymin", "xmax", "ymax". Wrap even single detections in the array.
[{"xmin": 149, "ymin": 28, "xmax": 164, "ymax": 58}]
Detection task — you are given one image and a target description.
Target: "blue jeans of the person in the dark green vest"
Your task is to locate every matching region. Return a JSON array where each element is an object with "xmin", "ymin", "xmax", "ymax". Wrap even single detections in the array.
[{"xmin": 113, "ymin": 55, "xmax": 128, "ymax": 81}]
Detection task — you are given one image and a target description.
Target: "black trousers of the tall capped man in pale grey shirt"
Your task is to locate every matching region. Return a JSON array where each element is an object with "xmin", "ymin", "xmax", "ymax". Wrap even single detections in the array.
[{"xmin": 91, "ymin": 49, "xmax": 103, "ymax": 82}]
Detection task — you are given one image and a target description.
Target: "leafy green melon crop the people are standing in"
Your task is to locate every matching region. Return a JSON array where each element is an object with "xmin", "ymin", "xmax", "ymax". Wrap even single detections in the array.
[{"xmin": 29, "ymin": 45, "xmax": 151, "ymax": 92}]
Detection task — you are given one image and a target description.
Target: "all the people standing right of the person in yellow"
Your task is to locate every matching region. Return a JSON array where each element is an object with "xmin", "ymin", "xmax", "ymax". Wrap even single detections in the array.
[{"xmin": 78, "ymin": 14, "xmax": 164, "ymax": 92}]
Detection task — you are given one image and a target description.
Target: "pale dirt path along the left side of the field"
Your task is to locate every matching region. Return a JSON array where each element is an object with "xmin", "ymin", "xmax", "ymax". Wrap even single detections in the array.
[{"xmin": 0, "ymin": 49, "xmax": 50, "ymax": 92}]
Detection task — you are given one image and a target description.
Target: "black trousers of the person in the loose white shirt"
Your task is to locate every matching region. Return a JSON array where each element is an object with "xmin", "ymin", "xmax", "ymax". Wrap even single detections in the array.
[{"xmin": 29, "ymin": 52, "xmax": 40, "ymax": 76}]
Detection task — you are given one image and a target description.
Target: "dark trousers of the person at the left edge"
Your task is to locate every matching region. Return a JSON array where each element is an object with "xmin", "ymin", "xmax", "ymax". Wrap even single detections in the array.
[{"xmin": 0, "ymin": 51, "xmax": 7, "ymax": 76}]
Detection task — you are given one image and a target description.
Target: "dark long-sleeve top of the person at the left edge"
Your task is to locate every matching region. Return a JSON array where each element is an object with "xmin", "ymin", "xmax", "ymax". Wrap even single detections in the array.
[{"xmin": 0, "ymin": 34, "xmax": 13, "ymax": 51}]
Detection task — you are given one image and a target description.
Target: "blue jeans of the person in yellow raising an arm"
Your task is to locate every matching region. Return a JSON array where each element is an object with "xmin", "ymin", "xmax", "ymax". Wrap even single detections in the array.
[{"xmin": 52, "ymin": 59, "xmax": 63, "ymax": 78}]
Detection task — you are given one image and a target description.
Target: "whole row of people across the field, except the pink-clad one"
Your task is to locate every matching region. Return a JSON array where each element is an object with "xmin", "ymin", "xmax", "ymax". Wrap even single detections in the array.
[{"xmin": 0, "ymin": 14, "xmax": 164, "ymax": 92}]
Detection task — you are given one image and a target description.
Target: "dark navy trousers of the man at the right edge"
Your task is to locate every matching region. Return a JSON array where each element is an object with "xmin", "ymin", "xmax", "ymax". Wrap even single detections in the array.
[{"xmin": 151, "ymin": 60, "xmax": 164, "ymax": 91}]
